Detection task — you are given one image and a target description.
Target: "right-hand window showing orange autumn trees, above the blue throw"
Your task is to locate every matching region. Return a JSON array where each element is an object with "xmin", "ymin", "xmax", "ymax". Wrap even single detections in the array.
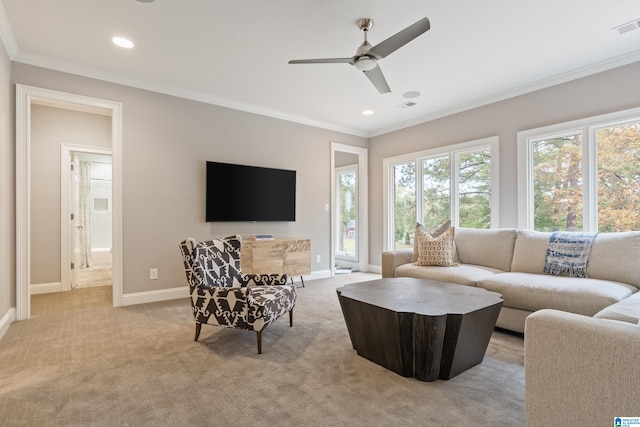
[{"xmin": 518, "ymin": 109, "xmax": 640, "ymax": 232}]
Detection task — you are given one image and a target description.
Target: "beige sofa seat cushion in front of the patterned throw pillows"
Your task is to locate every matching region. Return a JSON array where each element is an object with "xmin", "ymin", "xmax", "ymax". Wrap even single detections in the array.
[{"xmin": 395, "ymin": 264, "xmax": 502, "ymax": 286}]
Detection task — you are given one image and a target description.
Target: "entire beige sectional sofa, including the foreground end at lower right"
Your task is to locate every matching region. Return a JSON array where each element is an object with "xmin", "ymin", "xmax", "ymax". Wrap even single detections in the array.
[{"xmin": 382, "ymin": 228, "xmax": 640, "ymax": 427}]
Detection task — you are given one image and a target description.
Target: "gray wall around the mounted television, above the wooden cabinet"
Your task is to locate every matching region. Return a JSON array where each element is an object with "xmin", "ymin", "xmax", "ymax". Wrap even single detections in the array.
[{"xmin": 11, "ymin": 63, "xmax": 367, "ymax": 298}]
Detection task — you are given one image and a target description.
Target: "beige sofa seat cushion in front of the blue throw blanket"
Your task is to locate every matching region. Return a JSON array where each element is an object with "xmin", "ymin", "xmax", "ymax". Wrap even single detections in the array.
[{"xmin": 478, "ymin": 272, "xmax": 637, "ymax": 316}]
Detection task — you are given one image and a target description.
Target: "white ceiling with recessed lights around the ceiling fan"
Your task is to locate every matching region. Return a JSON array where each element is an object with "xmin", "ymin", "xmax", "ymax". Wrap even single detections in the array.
[{"xmin": 0, "ymin": 0, "xmax": 640, "ymax": 136}]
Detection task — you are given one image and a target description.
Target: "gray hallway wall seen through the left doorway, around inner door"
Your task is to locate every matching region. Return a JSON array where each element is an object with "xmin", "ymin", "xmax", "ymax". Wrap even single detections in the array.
[{"xmin": 31, "ymin": 105, "xmax": 111, "ymax": 284}]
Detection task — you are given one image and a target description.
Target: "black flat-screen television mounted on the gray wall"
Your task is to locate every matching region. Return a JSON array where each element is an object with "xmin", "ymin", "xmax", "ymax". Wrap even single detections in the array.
[{"xmin": 205, "ymin": 162, "xmax": 296, "ymax": 222}]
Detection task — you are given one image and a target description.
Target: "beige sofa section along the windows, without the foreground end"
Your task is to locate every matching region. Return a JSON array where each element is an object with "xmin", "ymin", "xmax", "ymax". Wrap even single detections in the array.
[{"xmin": 382, "ymin": 228, "xmax": 640, "ymax": 332}]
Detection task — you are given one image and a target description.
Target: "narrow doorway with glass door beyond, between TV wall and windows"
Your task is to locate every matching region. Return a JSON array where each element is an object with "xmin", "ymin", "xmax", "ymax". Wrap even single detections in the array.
[{"xmin": 331, "ymin": 143, "xmax": 368, "ymax": 275}]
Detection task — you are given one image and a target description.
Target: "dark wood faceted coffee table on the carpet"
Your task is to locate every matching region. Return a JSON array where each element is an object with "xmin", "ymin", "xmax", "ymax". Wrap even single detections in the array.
[{"xmin": 337, "ymin": 278, "xmax": 502, "ymax": 381}]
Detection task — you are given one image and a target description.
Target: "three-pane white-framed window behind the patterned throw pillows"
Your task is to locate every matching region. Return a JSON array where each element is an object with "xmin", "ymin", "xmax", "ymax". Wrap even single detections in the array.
[{"xmin": 384, "ymin": 137, "xmax": 498, "ymax": 249}]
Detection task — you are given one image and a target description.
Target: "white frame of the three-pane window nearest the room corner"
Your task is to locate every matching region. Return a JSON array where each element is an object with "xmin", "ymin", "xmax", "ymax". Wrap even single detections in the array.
[{"xmin": 382, "ymin": 136, "xmax": 500, "ymax": 250}]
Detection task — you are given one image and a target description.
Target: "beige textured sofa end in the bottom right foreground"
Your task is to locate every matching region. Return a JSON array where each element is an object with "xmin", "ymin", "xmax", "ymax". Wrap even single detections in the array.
[{"xmin": 524, "ymin": 310, "xmax": 640, "ymax": 427}]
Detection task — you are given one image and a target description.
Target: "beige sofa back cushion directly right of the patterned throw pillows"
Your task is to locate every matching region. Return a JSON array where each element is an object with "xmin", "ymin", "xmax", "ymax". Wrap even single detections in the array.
[{"xmin": 454, "ymin": 228, "xmax": 516, "ymax": 271}]
